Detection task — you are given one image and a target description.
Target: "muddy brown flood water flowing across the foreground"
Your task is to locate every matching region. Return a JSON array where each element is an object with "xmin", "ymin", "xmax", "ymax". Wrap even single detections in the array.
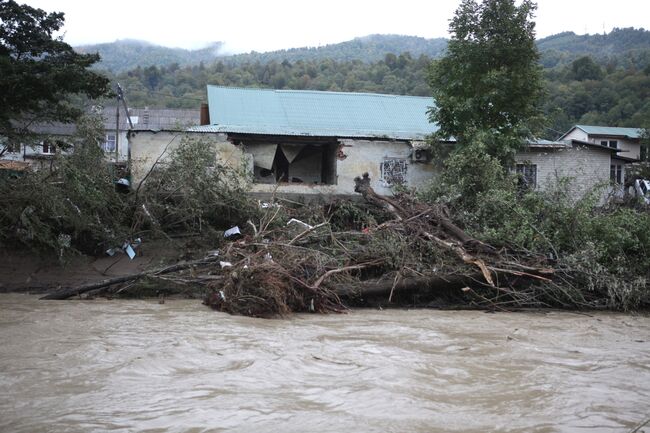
[{"xmin": 0, "ymin": 294, "xmax": 650, "ymax": 432}]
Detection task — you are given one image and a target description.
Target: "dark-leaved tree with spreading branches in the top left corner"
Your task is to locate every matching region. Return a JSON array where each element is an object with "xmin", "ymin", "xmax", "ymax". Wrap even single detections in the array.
[{"xmin": 0, "ymin": 0, "xmax": 109, "ymax": 150}]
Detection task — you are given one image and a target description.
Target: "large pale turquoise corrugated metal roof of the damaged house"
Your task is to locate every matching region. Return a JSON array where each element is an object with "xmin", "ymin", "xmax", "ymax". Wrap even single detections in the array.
[{"xmin": 200, "ymin": 86, "xmax": 438, "ymax": 140}]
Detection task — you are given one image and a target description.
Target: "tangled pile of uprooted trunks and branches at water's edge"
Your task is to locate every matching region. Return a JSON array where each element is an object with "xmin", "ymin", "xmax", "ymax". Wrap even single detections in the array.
[{"xmin": 40, "ymin": 174, "xmax": 565, "ymax": 317}]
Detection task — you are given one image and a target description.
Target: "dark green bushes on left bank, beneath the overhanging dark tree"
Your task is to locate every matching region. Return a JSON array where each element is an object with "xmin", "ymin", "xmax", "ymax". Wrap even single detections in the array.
[{"xmin": 0, "ymin": 117, "xmax": 127, "ymax": 257}]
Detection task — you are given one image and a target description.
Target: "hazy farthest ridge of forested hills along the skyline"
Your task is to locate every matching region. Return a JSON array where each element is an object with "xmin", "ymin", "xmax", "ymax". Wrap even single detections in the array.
[{"xmin": 81, "ymin": 28, "xmax": 650, "ymax": 73}]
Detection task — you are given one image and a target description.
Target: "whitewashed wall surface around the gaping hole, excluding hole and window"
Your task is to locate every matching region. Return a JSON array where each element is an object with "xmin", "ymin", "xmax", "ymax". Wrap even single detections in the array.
[{"xmin": 129, "ymin": 131, "xmax": 437, "ymax": 196}]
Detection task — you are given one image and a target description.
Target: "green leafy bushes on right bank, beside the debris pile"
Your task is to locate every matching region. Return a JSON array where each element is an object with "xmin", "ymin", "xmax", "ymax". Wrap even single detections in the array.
[{"xmin": 421, "ymin": 152, "xmax": 650, "ymax": 310}]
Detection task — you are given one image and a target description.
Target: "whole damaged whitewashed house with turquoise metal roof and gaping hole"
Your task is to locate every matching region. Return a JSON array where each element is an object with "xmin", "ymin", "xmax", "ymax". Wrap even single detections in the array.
[{"xmin": 130, "ymin": 86, "xmax": 437, "ymax": 196}]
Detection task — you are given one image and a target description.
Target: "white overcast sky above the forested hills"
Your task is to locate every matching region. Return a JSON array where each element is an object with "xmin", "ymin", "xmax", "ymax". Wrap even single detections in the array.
[{"xmin": 17, "ymin": 0, "xmax": 650, "ymax": 52}]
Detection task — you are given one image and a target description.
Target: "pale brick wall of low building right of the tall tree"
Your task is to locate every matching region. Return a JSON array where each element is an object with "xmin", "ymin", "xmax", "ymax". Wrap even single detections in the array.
[{"xmin": 515, "ymin": 146, "xmax": 611, "ymax": 199}]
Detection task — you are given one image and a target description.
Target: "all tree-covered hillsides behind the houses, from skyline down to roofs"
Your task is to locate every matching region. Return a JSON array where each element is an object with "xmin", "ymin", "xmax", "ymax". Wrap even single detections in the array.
[{"xmin": 95, "ymin": 29, "xmax": 650, "ymax": 138}]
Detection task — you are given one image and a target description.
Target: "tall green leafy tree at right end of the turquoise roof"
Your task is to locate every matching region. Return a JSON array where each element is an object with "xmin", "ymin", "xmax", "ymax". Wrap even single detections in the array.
[{"xmin": 429, "ymin": 0, "xmax": 543, "ymax": 161}]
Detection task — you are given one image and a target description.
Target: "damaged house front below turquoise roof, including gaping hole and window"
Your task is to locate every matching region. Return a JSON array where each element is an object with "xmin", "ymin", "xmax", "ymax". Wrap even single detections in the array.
[{"xmin": 129, "ymin": 131, "xmax": 438, "ymax": 196}]
